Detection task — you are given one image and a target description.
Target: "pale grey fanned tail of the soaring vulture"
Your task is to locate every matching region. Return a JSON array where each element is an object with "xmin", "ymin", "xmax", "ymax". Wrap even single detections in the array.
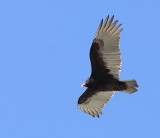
[{"xmin": 121, "ymin": 80, "xmax": 138, "ymax": 93}]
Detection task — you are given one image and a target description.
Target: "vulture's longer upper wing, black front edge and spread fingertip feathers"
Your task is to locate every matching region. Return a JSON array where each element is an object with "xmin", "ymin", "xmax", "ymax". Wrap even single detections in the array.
[{"xmin": 90, "ymin": 16, "xmax": 123, "ymax": 78}]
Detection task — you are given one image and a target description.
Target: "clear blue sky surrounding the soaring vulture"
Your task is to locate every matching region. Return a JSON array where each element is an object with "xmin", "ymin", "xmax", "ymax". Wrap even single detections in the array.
[{"xmin": 0, "ymin": 0, "xmax": 160, "ymax": 138}]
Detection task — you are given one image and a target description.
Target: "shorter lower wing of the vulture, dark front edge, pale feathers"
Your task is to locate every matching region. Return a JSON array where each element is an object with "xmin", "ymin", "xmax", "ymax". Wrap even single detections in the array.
[{"xmin": 78, "ymin": 88, "xmax": 114, "ymax": 118}]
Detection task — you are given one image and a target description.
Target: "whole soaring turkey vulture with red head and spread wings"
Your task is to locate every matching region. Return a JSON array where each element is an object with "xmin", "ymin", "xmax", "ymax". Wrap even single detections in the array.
[{"xmin": 78, "ymin": 16, "xmax": 138, "ymax": 118}]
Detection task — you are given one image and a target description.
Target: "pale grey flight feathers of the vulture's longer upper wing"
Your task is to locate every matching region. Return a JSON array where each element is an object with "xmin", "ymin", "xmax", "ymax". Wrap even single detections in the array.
[{"xmin": 94, "ymin": 16, "xmax": 123, "ymax": 78}]
